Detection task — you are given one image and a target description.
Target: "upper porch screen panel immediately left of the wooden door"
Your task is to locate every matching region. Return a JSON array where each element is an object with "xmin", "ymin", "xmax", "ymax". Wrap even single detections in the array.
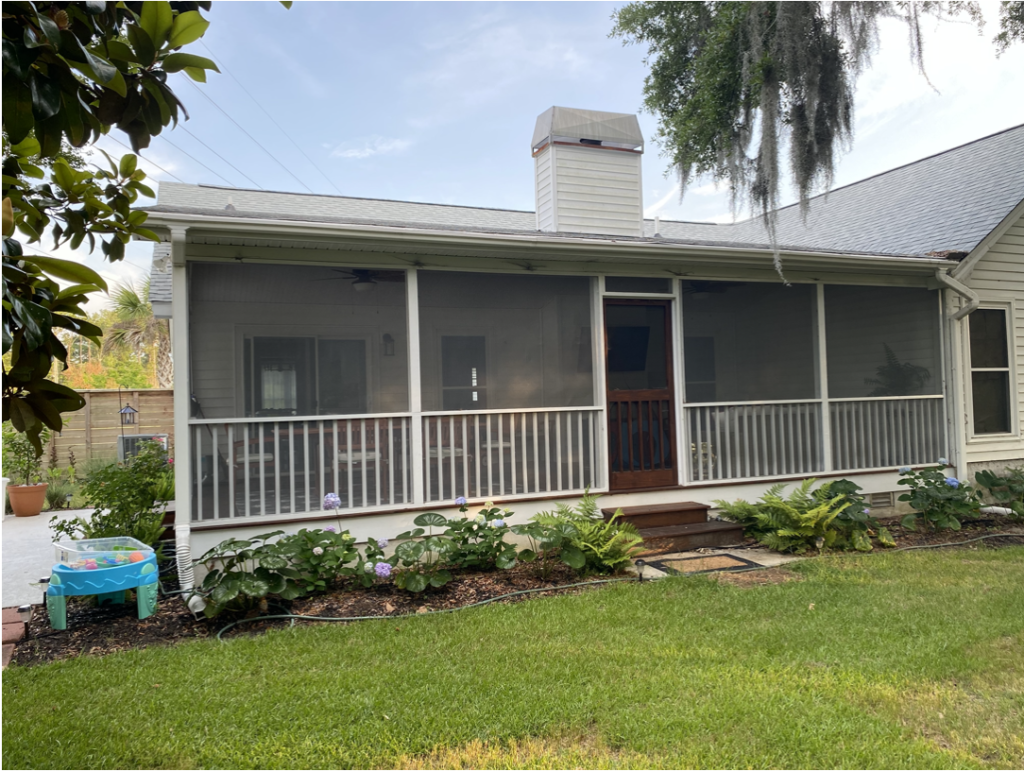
[{"xmin": 419, "ymin": 270, "xmax": 594, "ymax": 412}]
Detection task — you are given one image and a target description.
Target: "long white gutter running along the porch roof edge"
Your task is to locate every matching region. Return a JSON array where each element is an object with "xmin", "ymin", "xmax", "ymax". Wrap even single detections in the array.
[{"xmin": 140, "ymin": 212, "xmax": 949, "ymax": 270}]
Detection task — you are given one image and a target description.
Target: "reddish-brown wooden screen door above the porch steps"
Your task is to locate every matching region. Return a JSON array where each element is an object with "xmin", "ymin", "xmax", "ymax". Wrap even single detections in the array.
[{"xmin": 604, "ymin": 300, "xmax": 677, "ymax": 490}]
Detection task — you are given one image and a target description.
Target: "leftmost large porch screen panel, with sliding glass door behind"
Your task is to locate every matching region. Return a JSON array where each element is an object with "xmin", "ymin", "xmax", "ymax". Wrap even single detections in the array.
[{"xmin": 189, "ymin": 263, "xmax": 409, "ymax": 418}]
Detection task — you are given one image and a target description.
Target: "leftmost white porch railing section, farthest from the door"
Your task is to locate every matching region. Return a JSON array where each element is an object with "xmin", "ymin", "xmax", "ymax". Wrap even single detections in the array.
[{"xmin": 189, "ymin": 414, "xmax": 413, "ymax": 521}]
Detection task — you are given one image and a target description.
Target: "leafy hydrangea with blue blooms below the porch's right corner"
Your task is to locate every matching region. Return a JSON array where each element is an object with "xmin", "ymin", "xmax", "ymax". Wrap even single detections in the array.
[{"xmin": 898, "ymin": 458, "xmax": 981, "ymax": 530}]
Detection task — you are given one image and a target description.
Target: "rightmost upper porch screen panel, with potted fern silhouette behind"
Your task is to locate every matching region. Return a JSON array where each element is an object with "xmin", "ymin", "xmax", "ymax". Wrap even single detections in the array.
[{"xmin": 825, "ymin": 287, "xmax": 942, "ymax": 398}]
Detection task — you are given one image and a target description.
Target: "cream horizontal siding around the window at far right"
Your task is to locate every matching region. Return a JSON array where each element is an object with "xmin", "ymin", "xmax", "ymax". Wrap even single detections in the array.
[{"xmin": 964, "ymin": 210, "xmax": 1024, "ymax": 463}]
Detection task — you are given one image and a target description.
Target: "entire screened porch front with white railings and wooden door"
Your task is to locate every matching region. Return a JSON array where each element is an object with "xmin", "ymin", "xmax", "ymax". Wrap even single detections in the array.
[{"xmin": 182, "ymin": 262, "xmax": 945, "ymax": 522}]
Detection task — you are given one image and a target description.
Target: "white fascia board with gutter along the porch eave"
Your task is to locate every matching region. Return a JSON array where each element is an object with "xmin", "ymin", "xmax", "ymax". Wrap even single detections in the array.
[{"xmin": 140, "ymin": 212, "xmax": 951, "ymax": 273}]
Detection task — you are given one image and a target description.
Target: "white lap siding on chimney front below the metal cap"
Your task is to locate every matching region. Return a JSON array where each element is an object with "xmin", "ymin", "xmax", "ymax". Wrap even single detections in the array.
[{"xmin": 538, "ymin": 145, "xmax": 643, "ymax": 235}]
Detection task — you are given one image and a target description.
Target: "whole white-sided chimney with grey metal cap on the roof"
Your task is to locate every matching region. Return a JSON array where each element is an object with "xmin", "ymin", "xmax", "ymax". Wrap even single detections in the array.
[{"xmin": 532, "ymin": 108, "xmax": 643, "ymax": 235}]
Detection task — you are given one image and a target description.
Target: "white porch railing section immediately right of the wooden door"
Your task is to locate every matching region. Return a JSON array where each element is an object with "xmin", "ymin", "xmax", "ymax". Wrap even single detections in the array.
[{"xmin": 681, "ymin": 401, "xmax": 824, "ymax": 482}]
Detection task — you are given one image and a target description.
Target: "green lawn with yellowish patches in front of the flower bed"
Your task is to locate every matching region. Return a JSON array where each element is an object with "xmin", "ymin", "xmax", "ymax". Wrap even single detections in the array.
[{"xmin": 3, "ymin": 548, "xmax": 1024, "ymax": 768}]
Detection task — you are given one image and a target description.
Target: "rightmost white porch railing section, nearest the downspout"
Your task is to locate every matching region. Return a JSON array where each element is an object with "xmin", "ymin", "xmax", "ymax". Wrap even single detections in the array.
[{"xmin": 829, "ymin": 396, "xmax": 946, "ymax": 469}]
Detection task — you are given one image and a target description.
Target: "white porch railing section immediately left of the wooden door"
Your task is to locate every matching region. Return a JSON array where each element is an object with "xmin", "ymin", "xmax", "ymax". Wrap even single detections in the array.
[{"xmin": 423, "ymin": 408, "xmax": 604, "ymax": 503}]
